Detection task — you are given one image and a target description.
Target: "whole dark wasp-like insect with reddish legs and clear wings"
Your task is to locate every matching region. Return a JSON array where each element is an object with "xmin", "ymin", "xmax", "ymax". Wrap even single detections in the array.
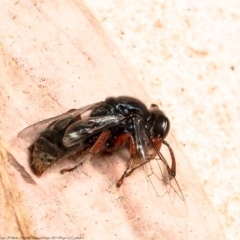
[{"xmin": 18, "ymin": 96, "xmax": 184, "ymax": 201}]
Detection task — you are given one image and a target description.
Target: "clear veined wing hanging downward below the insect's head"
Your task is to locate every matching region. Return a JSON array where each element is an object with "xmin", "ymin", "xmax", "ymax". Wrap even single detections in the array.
[{"xmin": 134, "ymin": 119, "xmax": 187, "ymax": 217}]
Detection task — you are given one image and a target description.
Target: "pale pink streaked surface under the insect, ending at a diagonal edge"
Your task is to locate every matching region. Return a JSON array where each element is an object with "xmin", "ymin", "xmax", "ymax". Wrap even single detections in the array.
[{"xmin": 0, "ymin": 1, "xmax": 229, "ymax": 239}]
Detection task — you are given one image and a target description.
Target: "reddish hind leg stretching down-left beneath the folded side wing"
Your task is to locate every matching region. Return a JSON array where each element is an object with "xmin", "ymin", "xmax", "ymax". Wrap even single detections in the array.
[{"xmin": 60, "ymin": 130, "xmax": 110, "ymax": 174}]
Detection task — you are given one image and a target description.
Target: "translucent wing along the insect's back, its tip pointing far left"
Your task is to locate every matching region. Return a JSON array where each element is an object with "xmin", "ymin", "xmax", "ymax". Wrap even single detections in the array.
[{"xmin": 18, "ymin": 102, "xmax": 102, "ymax": 139}]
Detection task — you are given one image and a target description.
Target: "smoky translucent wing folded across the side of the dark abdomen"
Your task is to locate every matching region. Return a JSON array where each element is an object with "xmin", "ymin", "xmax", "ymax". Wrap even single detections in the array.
[{"xmin": 63, "ymin": 116, "xmax": 125, "ymax": 147}]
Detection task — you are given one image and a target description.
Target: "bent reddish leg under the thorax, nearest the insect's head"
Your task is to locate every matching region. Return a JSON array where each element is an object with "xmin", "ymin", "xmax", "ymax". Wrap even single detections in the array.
[{"xmin": 112, "ymin": 133, "xmax": 137, "ymax": 188}]
